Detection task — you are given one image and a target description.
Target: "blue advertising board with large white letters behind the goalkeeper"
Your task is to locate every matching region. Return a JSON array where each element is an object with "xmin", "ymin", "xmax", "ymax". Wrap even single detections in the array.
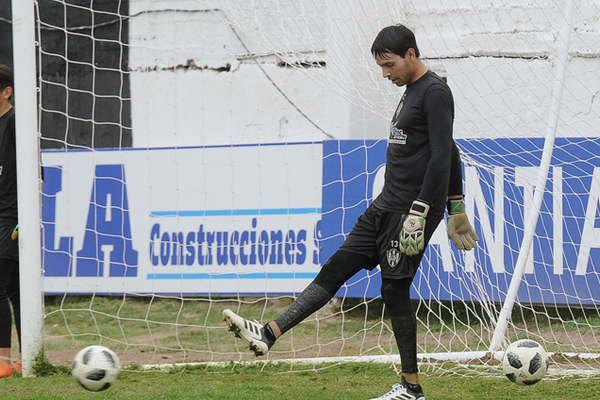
[{"xmin": 319, "ymin": 138, "xmax": 600, "ymax": 305}]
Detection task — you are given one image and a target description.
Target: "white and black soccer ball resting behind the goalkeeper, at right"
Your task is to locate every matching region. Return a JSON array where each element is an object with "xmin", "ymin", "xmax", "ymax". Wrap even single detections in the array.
[{"xmin": 502, "ymin": 339, "xmax": 549, "ymax": 385}]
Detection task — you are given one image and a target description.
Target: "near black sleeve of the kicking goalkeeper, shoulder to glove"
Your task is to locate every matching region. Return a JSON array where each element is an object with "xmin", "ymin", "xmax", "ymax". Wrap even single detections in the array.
[{"xmin": 418, "ymin": 85, "xmax": 454, "ymax": 204}]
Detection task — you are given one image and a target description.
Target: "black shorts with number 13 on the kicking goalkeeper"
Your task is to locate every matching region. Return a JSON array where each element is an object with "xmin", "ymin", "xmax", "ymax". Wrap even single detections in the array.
[{"xmin": 339, "ymin": 204, "xmax": 443, "ymax": 279}]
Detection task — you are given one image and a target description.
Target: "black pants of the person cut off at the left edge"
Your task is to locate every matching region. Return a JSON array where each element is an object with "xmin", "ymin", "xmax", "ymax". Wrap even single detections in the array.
[{"xmin": 0, "ymin": 258, "xmax": 21, "ymax": 348}]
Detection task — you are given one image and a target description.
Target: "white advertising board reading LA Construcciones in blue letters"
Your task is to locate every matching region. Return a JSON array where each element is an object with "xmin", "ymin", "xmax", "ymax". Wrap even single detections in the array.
[{"xmin": 43, "ymin": 143, "xmax": 322, "ymax": 295}]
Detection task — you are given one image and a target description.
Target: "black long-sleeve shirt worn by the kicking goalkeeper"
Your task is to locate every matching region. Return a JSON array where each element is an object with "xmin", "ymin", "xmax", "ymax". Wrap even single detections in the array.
[{"xmin": 375, "ymin": 71, "xmax": 462, "ymax": 215}]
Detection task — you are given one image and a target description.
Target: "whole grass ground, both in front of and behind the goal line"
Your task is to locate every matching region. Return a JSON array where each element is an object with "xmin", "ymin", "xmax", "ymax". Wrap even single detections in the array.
[{"xmin": 0, "ymin": 296, "xmax": 600, "ymax": 400}]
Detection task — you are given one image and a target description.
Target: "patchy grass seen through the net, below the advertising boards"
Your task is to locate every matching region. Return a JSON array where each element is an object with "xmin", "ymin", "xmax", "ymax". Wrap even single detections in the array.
[{"xmin": 39, "ymin": 296, "xmax": 600, "ymax": 367}]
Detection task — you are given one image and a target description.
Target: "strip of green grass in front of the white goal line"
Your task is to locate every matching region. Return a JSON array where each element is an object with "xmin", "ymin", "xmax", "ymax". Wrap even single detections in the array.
[{"xmin": 0, "ymin": 364, "xmax": 600, "ymax": 400}]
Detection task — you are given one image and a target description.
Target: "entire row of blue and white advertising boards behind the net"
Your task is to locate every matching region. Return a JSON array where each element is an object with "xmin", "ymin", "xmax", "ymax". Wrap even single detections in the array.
[{"xmin": 43, "ymin": 138, "xmax": 600, "ymax": 305}]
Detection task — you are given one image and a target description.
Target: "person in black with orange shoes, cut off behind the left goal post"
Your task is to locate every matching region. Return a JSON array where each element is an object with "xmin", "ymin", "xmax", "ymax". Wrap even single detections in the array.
[{"xmin": 0, "ymin": 64, "xmax": 21, "ymax": 378}]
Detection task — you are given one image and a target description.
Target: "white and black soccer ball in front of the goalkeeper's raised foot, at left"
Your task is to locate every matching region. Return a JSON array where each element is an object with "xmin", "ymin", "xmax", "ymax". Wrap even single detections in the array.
[{"xmin": 71, "ymin": 346, "xmax": 121, "ymax": 392}]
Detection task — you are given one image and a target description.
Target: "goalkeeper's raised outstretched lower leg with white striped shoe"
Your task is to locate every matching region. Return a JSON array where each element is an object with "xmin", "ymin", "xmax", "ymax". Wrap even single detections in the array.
[{"xmin": 223, "ymin": 251, "xmax": 368, "ymax": 356}]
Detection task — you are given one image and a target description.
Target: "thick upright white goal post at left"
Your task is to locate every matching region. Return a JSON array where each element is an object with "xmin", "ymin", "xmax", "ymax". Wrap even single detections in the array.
[{"xmin": 12, "ymin": 0, "xmax": 44, "ymax": 377}]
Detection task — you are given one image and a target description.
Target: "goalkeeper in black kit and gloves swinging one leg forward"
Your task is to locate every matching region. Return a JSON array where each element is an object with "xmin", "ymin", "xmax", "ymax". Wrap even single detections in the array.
[{"xmin": 223, "ymin": 25, "xmax": 479, "ymax": 400}]
